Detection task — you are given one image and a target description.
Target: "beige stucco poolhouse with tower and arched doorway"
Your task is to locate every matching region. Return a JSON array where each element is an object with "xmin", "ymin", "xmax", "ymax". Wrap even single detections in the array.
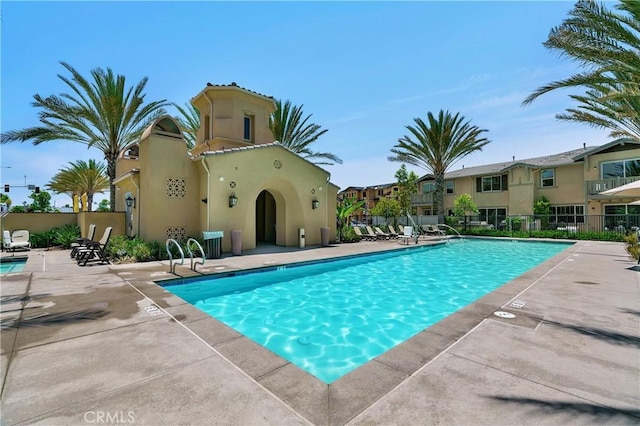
[{"xmin": 115, "ymin": 83, "xmax": 338, "ymax": 251}]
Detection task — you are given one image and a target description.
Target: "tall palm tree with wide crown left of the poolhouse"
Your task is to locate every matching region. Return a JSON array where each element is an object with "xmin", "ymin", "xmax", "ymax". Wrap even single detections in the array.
[{"xmin": 0, "ymin": 62, "xmax": 168, "ymax": 211}]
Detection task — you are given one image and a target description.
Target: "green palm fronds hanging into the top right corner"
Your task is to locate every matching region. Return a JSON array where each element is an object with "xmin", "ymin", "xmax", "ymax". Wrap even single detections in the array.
[{"xmin": 523, "ymin": 0, "xmax": 640, "ymax": 139}]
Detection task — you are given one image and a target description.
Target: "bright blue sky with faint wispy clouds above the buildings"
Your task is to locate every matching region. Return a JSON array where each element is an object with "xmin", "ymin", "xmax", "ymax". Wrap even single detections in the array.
[{"xmin": 0, "ymin": 1, "xmax": 610, "ymax": 206}]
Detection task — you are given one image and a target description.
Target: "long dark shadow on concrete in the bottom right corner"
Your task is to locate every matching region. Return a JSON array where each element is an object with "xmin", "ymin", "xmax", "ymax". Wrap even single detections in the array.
[{"xmin": 485, "ymin": 395, "xmax": 640, "ymax": 424}]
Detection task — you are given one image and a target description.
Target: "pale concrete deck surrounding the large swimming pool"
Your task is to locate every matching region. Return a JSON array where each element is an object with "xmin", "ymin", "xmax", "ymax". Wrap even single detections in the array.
[{"xmin": 0, "ymin": 241, "xmax": 640, "ymax": 425}]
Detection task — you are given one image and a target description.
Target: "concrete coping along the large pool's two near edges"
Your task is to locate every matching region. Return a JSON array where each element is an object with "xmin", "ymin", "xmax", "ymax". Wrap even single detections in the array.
[{"xmin": 122, "ymin": 240, "xmax": 576, "ymax": 425}]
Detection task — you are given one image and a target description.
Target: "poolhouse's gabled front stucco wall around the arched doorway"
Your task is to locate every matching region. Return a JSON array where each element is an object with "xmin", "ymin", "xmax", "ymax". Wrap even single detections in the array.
[{"xmin": 201, "ymin": 146, "xmax": 338, "ymax": 251}]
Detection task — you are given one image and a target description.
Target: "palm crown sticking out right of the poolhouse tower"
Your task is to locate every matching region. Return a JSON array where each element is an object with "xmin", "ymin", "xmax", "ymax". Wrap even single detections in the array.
[{"xmin": 269, "ymin": 99, "xmax": 342, "ymax": 164}]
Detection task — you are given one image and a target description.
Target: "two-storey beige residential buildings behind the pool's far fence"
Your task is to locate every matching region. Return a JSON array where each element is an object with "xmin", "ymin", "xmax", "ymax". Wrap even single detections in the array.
[{"xmin": 340, "ymin": 139, "xmax": 640, "ymax": 230}]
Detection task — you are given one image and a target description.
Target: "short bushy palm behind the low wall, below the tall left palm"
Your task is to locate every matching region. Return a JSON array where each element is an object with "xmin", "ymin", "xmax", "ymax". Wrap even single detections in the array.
[{"xmin": 45, "ymin": 160, "xmax": 109, "ymax": 211}]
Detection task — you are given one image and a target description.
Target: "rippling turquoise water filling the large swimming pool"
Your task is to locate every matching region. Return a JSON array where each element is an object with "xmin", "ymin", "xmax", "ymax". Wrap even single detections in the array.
[{"xmin": 165, "ymin": 240, "xmax": 569, "ymax": 383}]
